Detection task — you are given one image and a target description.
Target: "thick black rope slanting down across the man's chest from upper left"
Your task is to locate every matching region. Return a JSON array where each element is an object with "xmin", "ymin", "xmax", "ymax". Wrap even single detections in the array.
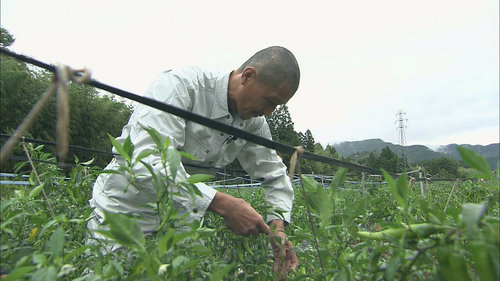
[{"xmin": 0, "ymin": 48, "xmax": 388, "ymax": 174}]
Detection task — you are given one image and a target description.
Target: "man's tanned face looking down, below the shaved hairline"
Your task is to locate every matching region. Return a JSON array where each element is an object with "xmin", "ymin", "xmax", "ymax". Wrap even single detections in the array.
[{"xmin": 236, "ymin": 81, "xmax": 294, "ymax": 119}]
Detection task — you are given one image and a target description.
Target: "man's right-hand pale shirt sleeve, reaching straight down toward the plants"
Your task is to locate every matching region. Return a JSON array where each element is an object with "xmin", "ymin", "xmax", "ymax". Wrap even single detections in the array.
[{"xmin": 238, "ymin": 120, "xmax": 294, "ymax": 223}]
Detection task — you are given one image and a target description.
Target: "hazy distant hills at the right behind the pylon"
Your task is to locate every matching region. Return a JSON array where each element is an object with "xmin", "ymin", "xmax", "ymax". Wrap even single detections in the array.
[{"xmin": 333, "ymin": 139, "xmax": 500, "ymax": 169}]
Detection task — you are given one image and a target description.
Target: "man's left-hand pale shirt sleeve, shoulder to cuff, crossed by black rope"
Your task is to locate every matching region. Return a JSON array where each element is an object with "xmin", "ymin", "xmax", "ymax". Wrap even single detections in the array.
[{"xmin": 121, "ymin": 73, "xmax": 216, "ymax": 220}]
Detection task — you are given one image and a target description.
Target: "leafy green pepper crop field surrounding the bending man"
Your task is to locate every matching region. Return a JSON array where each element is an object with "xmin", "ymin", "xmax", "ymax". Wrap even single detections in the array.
[{"xmin": 0, "ymin": 143, "xmax": 499, "ymax": 281}]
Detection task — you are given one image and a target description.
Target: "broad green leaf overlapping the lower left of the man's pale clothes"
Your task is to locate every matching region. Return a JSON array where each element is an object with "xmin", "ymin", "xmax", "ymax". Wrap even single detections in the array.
[{"xmin": 96, "ymin": 211, "xmax": 146, "ymax": 251}]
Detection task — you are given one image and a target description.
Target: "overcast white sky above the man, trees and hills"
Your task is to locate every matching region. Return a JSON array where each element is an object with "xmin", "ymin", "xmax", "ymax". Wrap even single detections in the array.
[{"xmin": 0, "ymin": 0, "xmax": 500, "ymax": 148}]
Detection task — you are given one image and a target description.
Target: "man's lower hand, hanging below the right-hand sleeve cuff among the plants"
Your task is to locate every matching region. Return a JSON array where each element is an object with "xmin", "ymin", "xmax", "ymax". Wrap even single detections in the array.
[{"xmin": 270, "ymin": 220, "xmax": 299, "ymax": 280}]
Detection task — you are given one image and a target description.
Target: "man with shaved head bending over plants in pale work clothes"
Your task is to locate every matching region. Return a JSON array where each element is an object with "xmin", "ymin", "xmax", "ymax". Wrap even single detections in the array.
[{"xmin": 89, "ymin": 46, "xmax": 300, "ymax": 276}]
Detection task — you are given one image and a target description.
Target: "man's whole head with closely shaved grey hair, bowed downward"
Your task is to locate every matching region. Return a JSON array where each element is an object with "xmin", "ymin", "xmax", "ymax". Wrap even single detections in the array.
[{"xmin": 228, "ymin": 46, "xmax": 300, "ymax": 119}]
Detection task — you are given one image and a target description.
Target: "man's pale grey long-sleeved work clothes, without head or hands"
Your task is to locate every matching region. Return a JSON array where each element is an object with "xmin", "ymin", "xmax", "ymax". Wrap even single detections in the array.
[{"xmin": 90, "ymin": 67, "xmax": 293, "ymax": 232}]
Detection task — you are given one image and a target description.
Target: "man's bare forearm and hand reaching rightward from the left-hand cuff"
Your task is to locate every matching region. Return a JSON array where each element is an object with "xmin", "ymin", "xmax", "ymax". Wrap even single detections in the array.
[{"xmin": 208, "ymin": 192, "xmax": 271, "ymax": 235}]
